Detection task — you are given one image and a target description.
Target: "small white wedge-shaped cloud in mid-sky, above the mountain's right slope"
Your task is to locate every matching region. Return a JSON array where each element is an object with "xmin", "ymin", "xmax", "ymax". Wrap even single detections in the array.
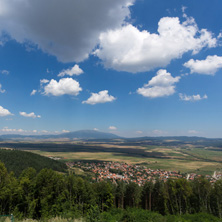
[{"xmin": 82, "ymin": 90, "xmax": 116, "ymax": 105}]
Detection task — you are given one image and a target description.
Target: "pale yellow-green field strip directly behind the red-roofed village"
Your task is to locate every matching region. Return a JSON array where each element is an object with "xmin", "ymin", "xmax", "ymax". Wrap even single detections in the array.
[{"xmin": 25, "ymin": 150, "xmax": 222, "ymax": 174}]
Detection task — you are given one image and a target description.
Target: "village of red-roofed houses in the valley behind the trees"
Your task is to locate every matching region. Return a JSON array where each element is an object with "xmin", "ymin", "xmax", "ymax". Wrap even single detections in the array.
[{"xmin": 66, "ymin": 161, "xmax": 221, "ymax": 186}]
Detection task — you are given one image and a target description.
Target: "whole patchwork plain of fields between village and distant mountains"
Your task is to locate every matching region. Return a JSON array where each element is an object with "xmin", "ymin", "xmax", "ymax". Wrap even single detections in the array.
[{"xmin": 0, "ymin": 140, "xmax": 222, "ymax": 175}]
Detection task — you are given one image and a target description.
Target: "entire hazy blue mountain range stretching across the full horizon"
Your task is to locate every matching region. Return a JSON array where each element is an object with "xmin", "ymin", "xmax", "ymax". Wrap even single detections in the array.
[{"xmin": 0, "ymin": 130, "xmax": 222, "ymax": 146}]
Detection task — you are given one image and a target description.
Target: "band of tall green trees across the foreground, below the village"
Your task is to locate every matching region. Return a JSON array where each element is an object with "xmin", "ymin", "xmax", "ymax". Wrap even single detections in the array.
[{"xmin": 0, "ymin": 160, "xmax": 222, "ymax": 222}]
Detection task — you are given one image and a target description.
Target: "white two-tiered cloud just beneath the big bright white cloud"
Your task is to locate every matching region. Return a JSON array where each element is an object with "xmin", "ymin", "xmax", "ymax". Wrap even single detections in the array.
[{"xmin": 137, "ymin": 69, "xmax": 180, "ymax": 98}]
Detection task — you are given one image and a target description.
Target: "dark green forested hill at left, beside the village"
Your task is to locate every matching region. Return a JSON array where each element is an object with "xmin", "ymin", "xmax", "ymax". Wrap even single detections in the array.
[{"xmin": 0, "ymin": 149, "xmax": 67, "ymax": 176}]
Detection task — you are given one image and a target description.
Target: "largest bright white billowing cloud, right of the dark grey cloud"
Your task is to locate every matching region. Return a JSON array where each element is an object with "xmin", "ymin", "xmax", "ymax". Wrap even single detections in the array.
[{"xmin": 94, "ymin": 17, "xmax": 217, "ymax": 73}]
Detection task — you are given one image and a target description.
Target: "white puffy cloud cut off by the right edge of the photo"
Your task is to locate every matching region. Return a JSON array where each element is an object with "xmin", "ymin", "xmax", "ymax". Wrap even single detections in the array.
[{"xmin": 184, "ymin": 55, "xmax": 222, "ymax": 75}]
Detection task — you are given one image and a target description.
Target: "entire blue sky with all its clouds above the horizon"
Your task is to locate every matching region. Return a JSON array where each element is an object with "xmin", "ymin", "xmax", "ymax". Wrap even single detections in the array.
[{"xmin": 0, "ymin": 0, "xmax": 222, "ymax": 137}]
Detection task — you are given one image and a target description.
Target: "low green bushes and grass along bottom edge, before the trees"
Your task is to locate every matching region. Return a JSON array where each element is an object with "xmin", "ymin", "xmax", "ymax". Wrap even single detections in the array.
[{"xmin": 0, "ymin": 211, "xmax": 222, "ymax": 222}]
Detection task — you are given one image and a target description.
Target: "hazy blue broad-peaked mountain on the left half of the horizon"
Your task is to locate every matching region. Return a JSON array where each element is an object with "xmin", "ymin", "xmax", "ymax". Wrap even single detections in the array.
[{"xmin": 0, "ymin": 130, "xmax": 121, "ymax": 140}]
